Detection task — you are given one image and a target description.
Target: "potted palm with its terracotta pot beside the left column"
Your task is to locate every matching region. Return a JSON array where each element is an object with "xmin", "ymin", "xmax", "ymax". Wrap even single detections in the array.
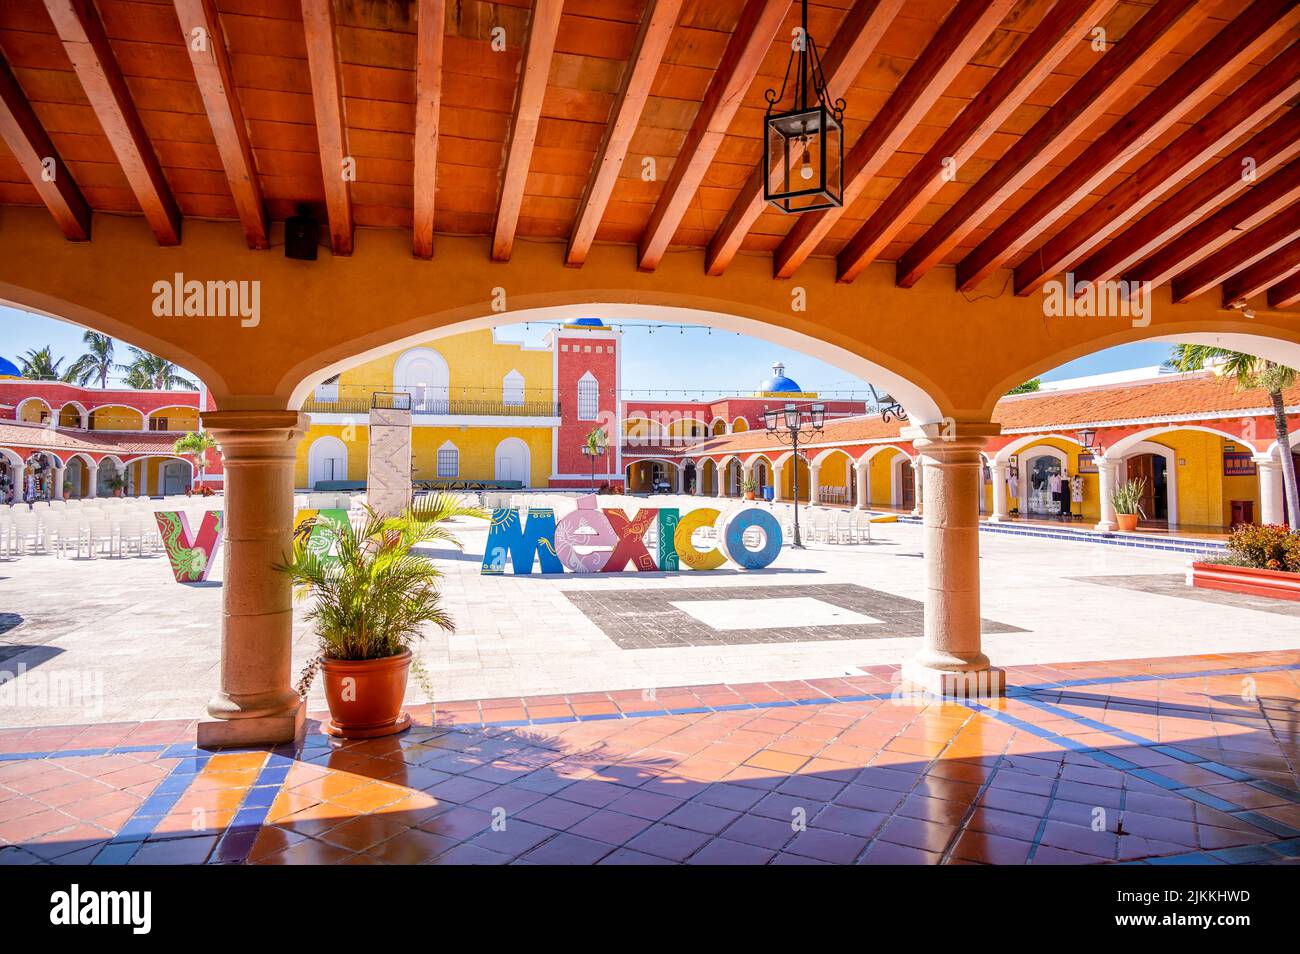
[{"xmin": 277, "ymin": 494, "xmax": 485, "ymax": 738}]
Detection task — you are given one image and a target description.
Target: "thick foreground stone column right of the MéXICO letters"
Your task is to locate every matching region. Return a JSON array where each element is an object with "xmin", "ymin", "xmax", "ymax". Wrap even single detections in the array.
[{"xmin": 902, "ymin": 422, "xmax": 1004, "ymax": 697}]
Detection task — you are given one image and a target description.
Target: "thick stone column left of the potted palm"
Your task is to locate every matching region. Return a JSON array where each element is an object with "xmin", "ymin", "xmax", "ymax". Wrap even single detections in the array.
[{"xmin": 199, "ymin": 411, "xmax": 308, "ymax": 746}]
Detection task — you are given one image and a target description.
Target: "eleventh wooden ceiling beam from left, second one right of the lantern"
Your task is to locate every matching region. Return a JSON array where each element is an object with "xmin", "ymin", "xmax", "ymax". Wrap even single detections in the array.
[{"xmin": 837, "ymin": 0, "xmax": 1118, "ymax": 282}]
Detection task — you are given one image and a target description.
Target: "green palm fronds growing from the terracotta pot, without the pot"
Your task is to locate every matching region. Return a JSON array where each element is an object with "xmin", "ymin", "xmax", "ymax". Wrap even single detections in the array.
[{"xmin": 276, "ymin": 494, "xmax": 486, "ymax": 694}]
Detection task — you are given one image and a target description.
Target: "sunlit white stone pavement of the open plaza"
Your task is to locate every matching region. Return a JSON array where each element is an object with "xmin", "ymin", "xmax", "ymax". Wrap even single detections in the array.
[{"xmin": 0, "ymin": 512, "xmax": 1300, "ymax": 725}]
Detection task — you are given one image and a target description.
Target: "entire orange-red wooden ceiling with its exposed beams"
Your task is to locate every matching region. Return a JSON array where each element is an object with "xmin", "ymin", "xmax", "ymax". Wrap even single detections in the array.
[{"xmin": 0, "ymin": 0, "xmax": 1300, "ymax": 307}]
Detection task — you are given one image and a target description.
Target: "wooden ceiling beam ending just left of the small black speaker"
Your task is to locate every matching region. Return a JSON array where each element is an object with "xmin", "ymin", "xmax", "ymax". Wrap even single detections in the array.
[{"xmin": 174, "ymin": 0, "xmax": 270, "ymax": 248}]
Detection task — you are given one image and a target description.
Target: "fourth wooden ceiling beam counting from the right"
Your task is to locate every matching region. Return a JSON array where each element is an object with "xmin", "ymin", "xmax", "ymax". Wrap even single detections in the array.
[{"xmin": 1125, "ymin": 161, "xmax": 1300, "ymax": 291}]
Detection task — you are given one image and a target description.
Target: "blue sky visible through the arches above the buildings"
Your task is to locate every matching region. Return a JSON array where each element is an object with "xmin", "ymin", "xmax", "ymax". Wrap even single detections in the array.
[{"xmin": 0, "ymin": 305, "xmax": 1169, "ymax": 398}]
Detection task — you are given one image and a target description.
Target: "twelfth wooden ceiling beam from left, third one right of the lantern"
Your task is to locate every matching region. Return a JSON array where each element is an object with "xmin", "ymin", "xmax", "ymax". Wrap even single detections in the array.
[{"xmin": 894, "ymin": 0, "xmax": 1209, "ymax": 289}]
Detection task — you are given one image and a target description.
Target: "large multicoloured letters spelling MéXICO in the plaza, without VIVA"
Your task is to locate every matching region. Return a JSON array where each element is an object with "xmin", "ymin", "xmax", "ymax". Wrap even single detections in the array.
[{"xmin": 482, "ymin": 496, "xmax": 781, "ymax": 573}]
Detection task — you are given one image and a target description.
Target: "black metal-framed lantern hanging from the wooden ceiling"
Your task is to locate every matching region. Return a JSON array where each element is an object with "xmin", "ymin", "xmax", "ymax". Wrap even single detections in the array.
[{"xmin": 763, "ymin": 0, "xmax": 845, "ymax": 213}]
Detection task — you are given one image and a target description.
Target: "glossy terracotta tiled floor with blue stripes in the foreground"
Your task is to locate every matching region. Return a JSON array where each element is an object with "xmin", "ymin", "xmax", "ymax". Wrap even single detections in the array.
[{"xmin": 0, "ymin": 652, "xmax": 1300, "ymax": 864}]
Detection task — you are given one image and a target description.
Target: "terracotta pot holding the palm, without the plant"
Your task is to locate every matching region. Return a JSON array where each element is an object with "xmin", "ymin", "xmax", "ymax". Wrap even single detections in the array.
[{"xmin": 321, "ymin": 650, "xmax": 411, "ymax": 738}]
